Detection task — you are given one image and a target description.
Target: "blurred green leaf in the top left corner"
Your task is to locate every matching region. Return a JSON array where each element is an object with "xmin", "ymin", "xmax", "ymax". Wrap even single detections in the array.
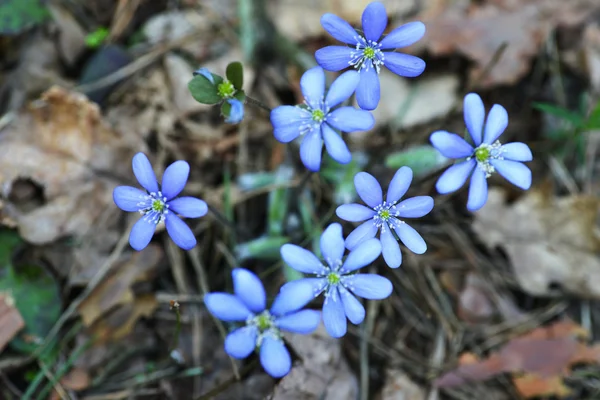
[{"xmin": 0, "ymin": 0, "xmax": 50, "ymax": 35}]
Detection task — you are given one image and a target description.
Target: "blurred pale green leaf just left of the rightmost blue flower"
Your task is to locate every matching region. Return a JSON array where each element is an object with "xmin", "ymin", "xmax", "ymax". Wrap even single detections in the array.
[{"xmin": 385, "ymin": 144, "xmax": 448, "ymax": 176}]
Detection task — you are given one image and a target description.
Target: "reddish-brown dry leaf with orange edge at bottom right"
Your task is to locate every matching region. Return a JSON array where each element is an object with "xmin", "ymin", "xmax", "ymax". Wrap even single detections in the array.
[{"xmin": 435, "ymin": 320, "xmax": 600, "ymax": 398}]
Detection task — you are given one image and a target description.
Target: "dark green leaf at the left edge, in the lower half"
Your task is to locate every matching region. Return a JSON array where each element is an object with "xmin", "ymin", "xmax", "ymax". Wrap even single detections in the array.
[{"xmin": 0, "ymin": 231, "xmax": 61, "ymax": 354}]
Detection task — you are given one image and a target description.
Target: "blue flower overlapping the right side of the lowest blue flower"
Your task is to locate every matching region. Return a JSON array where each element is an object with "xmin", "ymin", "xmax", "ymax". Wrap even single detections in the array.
[{"xmin": 281, "ymin": 223, "xmax": 392, "ymax": 338}]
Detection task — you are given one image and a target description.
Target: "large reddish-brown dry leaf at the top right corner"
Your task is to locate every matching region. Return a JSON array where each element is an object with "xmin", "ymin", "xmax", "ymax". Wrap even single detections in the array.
[{"xmin": 418, "ymin": 0, "xmax": 600, "ymax": 87}]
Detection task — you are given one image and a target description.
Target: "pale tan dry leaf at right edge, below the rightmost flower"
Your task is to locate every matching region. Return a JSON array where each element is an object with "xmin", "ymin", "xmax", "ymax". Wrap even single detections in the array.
[{"xmin": 473, "ymin": 188, "xmax": 600, "ymax": 299}]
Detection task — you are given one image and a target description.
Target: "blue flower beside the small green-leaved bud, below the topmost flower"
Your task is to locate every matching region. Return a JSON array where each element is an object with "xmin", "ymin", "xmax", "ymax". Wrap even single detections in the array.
[{"xmin": 271, "ymin": 67, "xmax": 375, "ymax": 171}]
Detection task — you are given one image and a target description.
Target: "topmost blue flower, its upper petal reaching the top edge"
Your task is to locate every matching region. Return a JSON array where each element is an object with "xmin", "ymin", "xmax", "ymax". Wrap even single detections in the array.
[{"xmin": 315, "ymin": 2, "xmax": 425, "ymax": 110}]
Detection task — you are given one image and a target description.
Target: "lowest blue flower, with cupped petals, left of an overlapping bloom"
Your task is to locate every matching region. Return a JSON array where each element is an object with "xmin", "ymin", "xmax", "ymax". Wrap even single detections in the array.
[{"xmin": 204, "ymin": 268, "xmax": 321, "ymax": 378}]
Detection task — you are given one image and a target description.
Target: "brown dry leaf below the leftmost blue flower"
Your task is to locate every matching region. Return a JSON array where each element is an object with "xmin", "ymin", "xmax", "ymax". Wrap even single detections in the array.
[{"xmin": 78, "ymin": 244, "xmax": 163, "ymax": 340}]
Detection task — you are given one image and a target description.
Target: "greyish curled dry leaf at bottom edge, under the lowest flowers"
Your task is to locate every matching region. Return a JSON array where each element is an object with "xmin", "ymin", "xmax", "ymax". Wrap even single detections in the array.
[{"xmin": 270, "ymin": 325, "xmax": 358, "ymax": 400}]
